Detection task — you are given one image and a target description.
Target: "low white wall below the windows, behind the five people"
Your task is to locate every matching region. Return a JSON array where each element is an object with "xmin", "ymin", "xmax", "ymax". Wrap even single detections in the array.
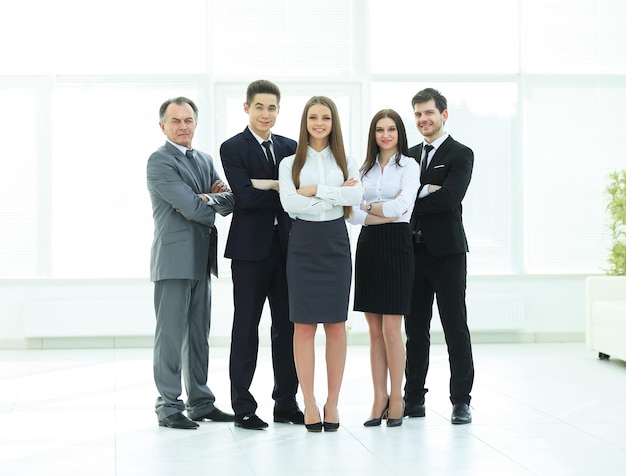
[{"xmin": 0, "ymin": 275, "xmax": 586, "ymax": 349}]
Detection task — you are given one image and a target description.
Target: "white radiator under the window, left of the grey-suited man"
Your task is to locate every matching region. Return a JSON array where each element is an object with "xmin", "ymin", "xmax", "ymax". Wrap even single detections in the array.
[{"xmin": 22, "ymin": 299, "xmax": 155, "ymax": 338}]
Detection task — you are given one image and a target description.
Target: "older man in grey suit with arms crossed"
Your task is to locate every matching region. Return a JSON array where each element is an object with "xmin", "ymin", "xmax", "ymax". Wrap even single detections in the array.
[{"xmin": 147, "ymin": 97, "xmax": 234, "ymax": 429}]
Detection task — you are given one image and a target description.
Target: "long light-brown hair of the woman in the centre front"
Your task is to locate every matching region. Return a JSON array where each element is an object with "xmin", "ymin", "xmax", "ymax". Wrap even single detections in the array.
[{"xmin": 291, "ymin": 96, "xmax": 352, "ymax": 218}]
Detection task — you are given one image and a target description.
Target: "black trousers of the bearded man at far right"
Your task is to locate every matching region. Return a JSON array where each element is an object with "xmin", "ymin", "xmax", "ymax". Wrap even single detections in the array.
[{"xmin": 404, "ymin": 243, "xmax": 474, "ymax": 404}]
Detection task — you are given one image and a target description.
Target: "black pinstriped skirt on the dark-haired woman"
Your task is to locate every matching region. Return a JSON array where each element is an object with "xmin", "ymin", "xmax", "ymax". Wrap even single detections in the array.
[{"xmin": 354, "ymin": 223, "xmax": 415, "ymax": 315}]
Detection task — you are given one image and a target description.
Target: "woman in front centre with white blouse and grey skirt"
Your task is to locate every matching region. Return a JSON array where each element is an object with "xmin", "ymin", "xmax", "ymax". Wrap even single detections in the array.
[{"xmin": 278, "ymin": 96, "xmax": 363, "ymax": 432}]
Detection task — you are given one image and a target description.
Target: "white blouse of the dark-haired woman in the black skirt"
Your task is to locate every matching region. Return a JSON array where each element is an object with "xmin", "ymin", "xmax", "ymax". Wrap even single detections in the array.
[{"xmin": 348, "ymin": 155, "xmax": 420, "ymax": 225}]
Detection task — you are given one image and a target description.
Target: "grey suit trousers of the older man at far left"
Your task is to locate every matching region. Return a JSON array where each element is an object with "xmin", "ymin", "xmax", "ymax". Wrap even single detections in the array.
[{"xmin": 154, "ymin": 275, "xmax": 215, "ymax": 420}]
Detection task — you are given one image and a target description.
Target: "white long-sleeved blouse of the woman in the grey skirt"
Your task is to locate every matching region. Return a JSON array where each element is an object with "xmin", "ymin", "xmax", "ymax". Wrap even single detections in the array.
[{"xmin": 278, "ymin": 147, "xmax": 363, "ymax": 221}]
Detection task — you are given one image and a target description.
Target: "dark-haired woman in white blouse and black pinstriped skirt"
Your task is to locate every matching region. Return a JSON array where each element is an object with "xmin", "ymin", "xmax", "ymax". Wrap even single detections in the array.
[{"xmin": 350, "ymin": 109, "xmax": 420, "ymax": 427}]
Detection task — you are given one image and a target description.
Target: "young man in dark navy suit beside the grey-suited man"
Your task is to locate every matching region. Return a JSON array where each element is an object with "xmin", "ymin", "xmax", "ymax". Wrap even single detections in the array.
[{"xmin": 220, "ymin": 80, "xmax": 304, "ymax": 430}]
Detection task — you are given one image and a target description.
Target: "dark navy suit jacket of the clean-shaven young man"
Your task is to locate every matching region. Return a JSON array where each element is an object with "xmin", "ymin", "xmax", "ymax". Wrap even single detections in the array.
[{"xmin": 220, "ymin": 127, "xmax": 296, "ymax": 261}]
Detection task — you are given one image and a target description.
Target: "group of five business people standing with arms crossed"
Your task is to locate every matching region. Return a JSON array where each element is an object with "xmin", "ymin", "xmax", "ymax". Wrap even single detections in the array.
[{"xmin": 147, "ymin": 80, "xmax": 473, "ymax": 432}]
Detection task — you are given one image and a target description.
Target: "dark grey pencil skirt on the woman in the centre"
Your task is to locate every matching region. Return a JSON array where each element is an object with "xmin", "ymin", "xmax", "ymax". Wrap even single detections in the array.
[{"xmin": 287, "ymin": 218, "xmax": 352, "ymax": 324}]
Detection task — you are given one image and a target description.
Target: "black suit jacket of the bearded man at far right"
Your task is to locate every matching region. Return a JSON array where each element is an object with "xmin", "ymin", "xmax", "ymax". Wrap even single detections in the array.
[{"xmin": 409, "ymin": 136, "xmax": 474, "ymax": 256}]
